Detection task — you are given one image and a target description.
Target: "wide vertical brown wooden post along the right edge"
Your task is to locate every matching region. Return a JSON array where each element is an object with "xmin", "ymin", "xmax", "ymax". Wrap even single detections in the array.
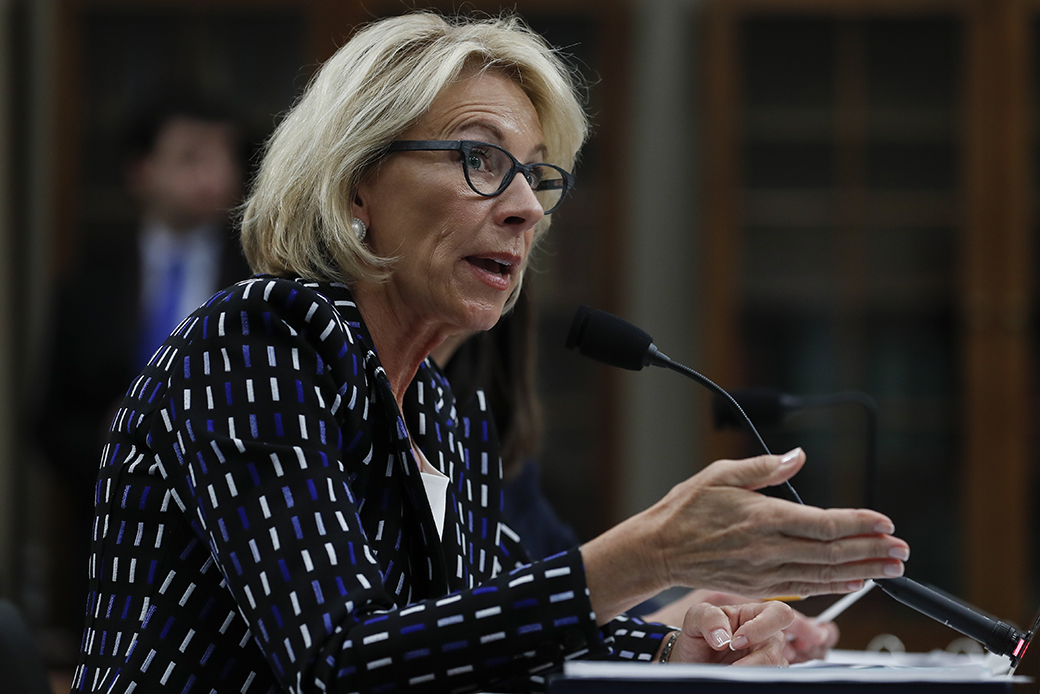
[{"xmin": 960, "ymin": 0, "xmax": 1035, "ymax": 621}]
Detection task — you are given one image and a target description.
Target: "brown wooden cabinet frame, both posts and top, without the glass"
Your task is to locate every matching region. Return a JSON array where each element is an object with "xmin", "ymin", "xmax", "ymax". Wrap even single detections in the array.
[{"xmin": 702, "ymin": 0, "xmax": 1040, "ymax": 622}]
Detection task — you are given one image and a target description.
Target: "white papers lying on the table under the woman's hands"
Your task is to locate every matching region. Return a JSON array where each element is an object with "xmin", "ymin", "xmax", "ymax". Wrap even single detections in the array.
[{"xmin": 564, "ymin": 650, "xmax": 1030, "ymax": 684}]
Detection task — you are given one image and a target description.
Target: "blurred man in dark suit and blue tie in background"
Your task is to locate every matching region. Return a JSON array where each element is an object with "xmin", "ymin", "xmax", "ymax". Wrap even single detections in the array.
[{"xmin": 38, "ymin": 92, "xmax": 250, "ymax": 659}]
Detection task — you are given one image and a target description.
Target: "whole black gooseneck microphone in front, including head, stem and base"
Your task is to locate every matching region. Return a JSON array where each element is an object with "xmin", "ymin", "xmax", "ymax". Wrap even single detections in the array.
[{"xmin": 567, "ymin": 306, "xmax": 1040, "ymax": 671}]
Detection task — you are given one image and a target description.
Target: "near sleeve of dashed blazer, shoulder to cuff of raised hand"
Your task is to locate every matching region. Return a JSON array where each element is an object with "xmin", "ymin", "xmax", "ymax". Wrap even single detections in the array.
[{"xmin": 150, "ymin": 280, "xmax": 606, "ymax": 692}]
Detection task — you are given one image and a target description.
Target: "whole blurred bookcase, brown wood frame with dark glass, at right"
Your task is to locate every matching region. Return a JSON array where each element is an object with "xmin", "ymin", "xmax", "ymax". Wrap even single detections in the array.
[{"xmin": 703, "ymin": 0, "xmax": 1038, "ymax": 647}]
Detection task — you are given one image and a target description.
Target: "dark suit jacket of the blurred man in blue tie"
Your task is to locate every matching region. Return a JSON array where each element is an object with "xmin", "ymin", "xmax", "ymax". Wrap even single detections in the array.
[{"xmin": 37, "ymin": 225, "xmax": 251, "ymax": 640}]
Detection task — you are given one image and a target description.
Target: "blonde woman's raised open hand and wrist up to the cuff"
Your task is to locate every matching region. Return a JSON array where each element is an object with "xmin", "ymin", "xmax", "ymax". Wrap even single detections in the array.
[{"xmin": 581, "ymin": 448, "xmax": 910, "ymax": 623}]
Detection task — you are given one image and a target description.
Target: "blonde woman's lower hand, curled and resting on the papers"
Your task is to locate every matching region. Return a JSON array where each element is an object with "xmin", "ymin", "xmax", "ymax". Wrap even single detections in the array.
[{"xmin": 669, "ymin": 601, "xmax": 795, "ymax": 667}]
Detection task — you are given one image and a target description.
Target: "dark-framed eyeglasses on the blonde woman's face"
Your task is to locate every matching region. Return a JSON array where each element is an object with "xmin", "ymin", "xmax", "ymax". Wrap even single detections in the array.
[{"xmin": 387, "ymin": 139, "xmax": 574, "ymax": 214}]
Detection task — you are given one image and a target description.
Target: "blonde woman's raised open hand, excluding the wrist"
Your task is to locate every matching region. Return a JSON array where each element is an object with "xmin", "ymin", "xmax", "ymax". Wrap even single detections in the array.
[{"xmin": 639, "ymin": 448, "xmax": 910, "ymax": 597}]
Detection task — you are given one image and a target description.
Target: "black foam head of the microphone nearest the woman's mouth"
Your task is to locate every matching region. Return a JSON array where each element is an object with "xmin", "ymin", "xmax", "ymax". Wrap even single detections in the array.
[{"xmin": 567, "ymin": 306, "xmax": 653, "ymax": 371}]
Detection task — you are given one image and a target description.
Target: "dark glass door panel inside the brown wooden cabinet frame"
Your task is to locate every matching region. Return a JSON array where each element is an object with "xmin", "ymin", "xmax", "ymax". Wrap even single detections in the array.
[{"xmin": 735, "ymin": 17, "xmax": 960, "ymax": 592}]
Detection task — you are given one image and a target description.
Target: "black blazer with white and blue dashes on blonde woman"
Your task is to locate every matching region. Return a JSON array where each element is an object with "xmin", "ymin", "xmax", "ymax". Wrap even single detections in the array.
[{"xmin": 74, "ymin": 276, "xmax": 667, "ymax": 694}]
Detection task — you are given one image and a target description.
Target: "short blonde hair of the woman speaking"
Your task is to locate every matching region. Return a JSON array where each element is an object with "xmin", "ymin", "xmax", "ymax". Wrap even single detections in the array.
[{"xmin": 241, "ymin": 12, "xmax": 588, "ymax": 285}]
